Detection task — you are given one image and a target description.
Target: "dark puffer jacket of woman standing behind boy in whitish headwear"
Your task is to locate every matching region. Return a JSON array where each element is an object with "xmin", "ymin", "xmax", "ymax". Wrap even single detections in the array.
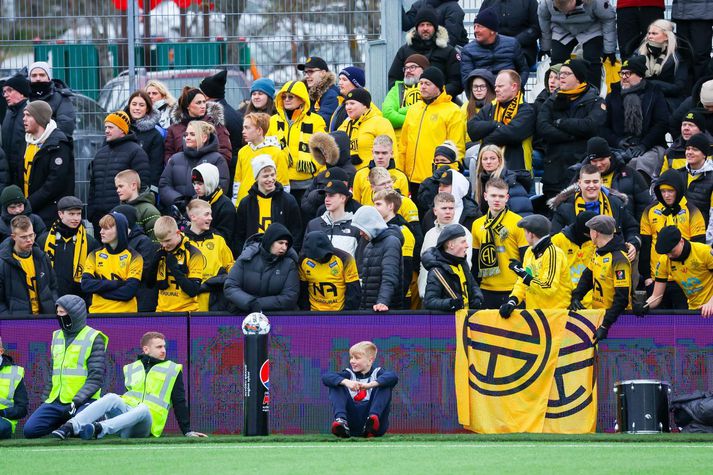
[{"xmin": 158, "ymin": 134, "xmax": 230, "ymax": 206}]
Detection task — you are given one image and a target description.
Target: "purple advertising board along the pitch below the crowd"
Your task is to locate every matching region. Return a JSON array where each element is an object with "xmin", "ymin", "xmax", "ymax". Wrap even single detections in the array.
[{"xmin": 0, "ymin": 312, "xmax": 713, "ymax": 434}]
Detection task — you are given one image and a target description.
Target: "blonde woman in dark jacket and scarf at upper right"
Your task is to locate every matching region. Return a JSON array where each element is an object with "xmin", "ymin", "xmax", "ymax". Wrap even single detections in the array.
[{"xmin": 636, "ymin": 19, "xmax": 690, "ymax": 111}]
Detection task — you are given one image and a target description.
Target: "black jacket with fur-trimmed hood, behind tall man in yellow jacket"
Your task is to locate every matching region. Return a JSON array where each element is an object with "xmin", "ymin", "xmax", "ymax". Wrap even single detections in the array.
[{"xmin": 389, "ymin": 26, "xmax": 463, "ymax": 101}]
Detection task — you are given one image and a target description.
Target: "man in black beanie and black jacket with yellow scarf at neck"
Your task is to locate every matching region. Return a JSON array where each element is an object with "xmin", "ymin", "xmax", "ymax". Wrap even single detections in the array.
[{"xmin": 536, "ymin": 59, "xmax": 607, "ymax": 198}]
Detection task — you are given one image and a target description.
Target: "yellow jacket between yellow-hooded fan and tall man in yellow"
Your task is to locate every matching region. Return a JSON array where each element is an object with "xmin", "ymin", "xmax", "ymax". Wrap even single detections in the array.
[{"xmin": 338, "ymin": 109, "xmax": 399, "ymax": 170}]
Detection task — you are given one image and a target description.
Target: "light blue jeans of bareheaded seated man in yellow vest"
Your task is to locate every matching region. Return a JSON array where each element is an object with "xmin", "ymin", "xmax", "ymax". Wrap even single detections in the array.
[{"xmin": 69, "ymin": 393, "xmax": 151, "ymax": 439}]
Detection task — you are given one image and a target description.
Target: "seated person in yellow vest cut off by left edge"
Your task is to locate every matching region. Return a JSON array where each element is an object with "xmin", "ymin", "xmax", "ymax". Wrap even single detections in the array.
[{"xmin": 0, "ymin": 338, "xmax": 29, "ymax": 440}]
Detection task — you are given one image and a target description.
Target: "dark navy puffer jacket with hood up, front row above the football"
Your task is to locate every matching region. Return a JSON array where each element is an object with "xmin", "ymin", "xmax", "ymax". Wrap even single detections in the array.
[{"xmin": 225, "ymin": 223, "xmax": 300, "ymax": 313}]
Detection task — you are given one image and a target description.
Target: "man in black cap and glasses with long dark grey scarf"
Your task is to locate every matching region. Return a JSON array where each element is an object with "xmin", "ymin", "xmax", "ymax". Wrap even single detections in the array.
[{"xmin": 600, "ymin": 56, "xmax": 668, "ymax": 178}]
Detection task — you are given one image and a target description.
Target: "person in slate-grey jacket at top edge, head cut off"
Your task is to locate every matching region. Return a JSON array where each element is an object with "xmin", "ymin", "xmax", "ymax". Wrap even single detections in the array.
[{"xmin": 537, "ymin": 0, "xmax": 616, "ymax": 87}]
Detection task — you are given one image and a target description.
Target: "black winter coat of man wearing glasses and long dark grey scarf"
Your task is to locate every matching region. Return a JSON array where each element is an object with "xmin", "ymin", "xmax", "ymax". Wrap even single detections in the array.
[{"xmin": 600, "ymin": 81, "xmax": 668, "ymax": 150}]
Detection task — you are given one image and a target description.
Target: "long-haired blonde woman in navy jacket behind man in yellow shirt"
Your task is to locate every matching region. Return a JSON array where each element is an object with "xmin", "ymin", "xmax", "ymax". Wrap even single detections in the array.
[{"xmin": 472, "ymin": 145, "xmax": 533, "ymax": 217}]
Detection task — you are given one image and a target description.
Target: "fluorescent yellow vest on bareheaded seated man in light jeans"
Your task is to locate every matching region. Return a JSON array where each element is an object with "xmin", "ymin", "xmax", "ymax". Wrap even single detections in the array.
[{"xmin": 121, "ymin": 361, "xmax": 183, "ymax": 437}]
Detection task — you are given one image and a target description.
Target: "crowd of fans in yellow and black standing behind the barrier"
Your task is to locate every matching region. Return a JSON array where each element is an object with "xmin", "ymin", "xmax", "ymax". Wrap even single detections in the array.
[{"xmin": 0, "ymin": 0, "xmax": 713, "ymax": 433}]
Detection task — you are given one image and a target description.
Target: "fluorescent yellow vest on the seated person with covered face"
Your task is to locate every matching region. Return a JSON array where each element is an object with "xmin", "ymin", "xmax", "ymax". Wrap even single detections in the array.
[{"xmin": 45, "ymin": 326, "xmax": 109, "ymax": 404}]
